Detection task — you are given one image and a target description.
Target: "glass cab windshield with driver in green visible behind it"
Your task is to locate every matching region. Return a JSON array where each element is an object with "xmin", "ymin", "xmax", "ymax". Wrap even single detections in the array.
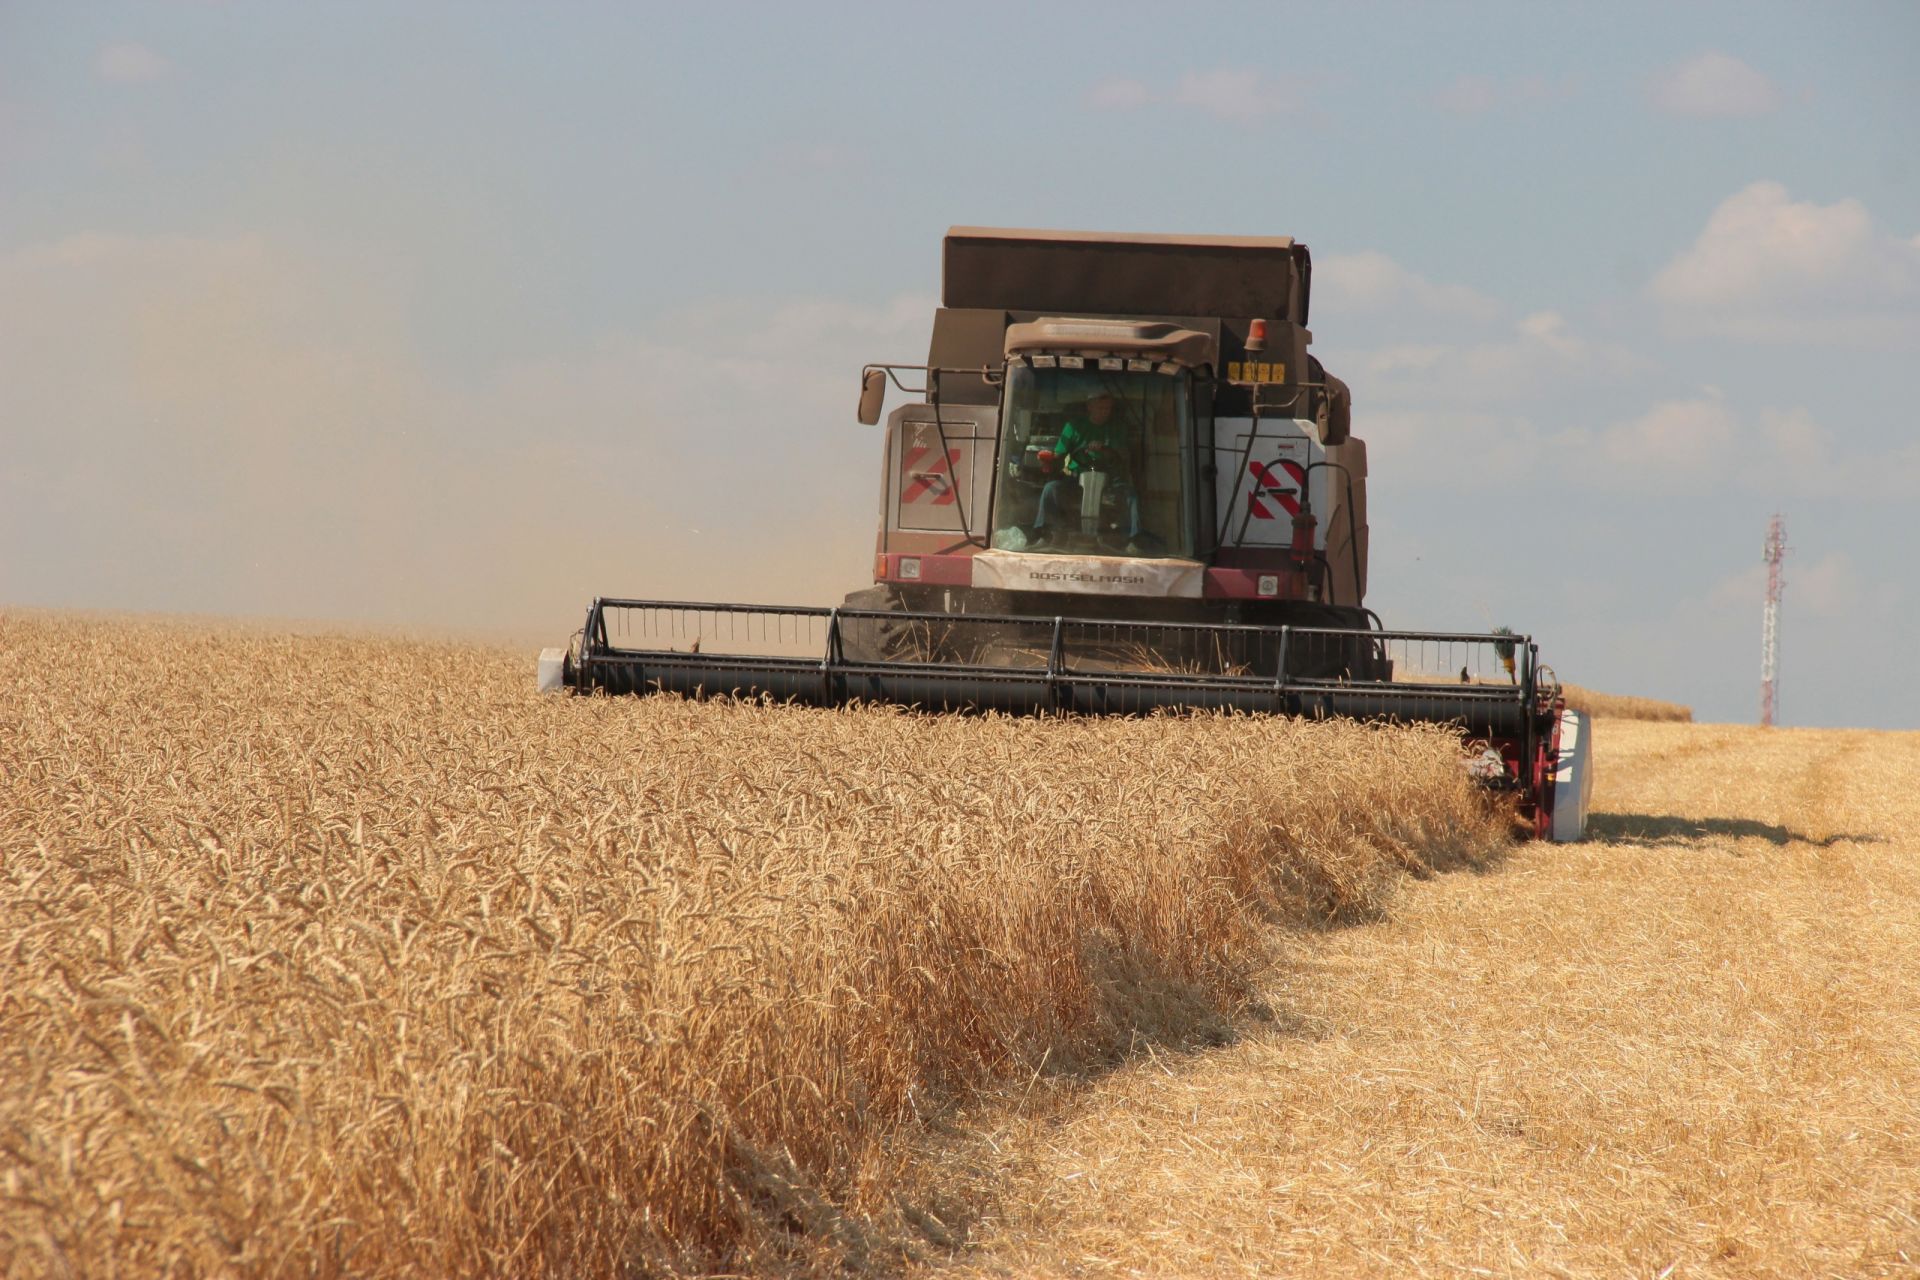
[{"xmin": 993, "ymin": 361, "xmax": 1194, "ymax": 557}]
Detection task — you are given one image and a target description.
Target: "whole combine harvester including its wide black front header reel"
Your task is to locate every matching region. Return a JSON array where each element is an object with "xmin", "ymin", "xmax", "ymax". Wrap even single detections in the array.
[{"xmin": 540, "ymin": 226, "xmax": 1592, "ymax": 841}]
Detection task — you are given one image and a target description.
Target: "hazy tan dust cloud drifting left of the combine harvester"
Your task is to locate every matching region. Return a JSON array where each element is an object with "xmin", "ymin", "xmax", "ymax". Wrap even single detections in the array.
[{"xmin": 0, "ymin": 236, "xmax": 931, "ymax": 643}]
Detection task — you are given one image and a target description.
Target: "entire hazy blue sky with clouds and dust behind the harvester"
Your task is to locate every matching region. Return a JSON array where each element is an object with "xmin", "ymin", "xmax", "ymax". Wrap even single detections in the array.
[{"xmin": 0, "ymin": 2, "xmax": 1920, "ymax": 727}]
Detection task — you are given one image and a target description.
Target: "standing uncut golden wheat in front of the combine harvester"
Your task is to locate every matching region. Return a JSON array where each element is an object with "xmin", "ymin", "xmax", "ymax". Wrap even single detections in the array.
[{"xmin": 0, "ymin": 616, "xmax": 1503, "ymax": 1276}]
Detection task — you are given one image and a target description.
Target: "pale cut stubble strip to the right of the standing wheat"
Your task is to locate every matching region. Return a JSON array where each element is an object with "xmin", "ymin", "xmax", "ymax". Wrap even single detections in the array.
[{"xmin": 941, "ymin": 718, "xmax": 1920, "ymax": 1280}]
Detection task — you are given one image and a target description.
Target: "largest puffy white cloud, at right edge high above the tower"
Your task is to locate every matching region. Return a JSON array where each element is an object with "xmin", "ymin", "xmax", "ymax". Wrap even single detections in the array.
[{"xmin": 1647, "ymin": 182, "xmax": 1920, "ymax": 345}]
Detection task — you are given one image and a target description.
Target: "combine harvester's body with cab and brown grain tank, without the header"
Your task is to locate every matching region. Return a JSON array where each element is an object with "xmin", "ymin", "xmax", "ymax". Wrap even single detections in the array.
[{"xmin": 860, "ymin": 226, "xmax": 1369, "ymax": 628}]
